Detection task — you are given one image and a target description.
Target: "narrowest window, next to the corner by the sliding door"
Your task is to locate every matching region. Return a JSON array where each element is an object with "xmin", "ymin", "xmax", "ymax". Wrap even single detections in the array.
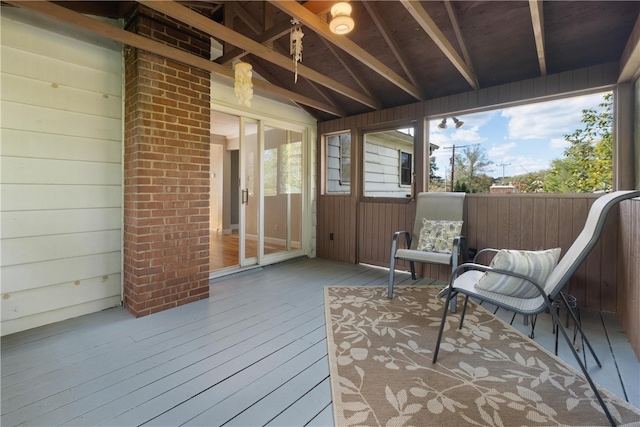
[{"xmin": 325, "ymin": 132, "xmax": 351, "ymax": 193}]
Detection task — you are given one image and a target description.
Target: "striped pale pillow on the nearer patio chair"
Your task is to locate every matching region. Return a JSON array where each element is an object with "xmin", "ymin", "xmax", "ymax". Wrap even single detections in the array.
[{"xmin": 476, "ymin": 248, "xmax": 560, "ymax": 298}]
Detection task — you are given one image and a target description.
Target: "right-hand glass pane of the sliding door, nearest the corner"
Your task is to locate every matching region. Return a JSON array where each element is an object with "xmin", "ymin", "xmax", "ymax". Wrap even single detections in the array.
[{"xmin": 262, "ymin": 126, "xmax": 304, "ymax": 255}]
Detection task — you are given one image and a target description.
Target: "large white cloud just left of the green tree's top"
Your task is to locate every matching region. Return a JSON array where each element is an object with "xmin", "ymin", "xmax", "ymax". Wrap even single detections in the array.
[{"xmin": 502, "ymin": 93, "xmax": 602, "ymax": 140}]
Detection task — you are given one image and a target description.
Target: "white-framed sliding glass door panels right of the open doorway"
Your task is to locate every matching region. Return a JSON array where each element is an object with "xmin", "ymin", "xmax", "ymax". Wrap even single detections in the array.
[{"xmin": 239, "ymin": 118, "xmax": 306, "ymax": 266}]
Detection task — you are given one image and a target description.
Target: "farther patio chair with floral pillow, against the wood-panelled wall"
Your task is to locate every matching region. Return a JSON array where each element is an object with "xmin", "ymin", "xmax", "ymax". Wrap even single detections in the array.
[{"xmin": 387, "ymin": 193, "xmax": 467, "ymax": 302}]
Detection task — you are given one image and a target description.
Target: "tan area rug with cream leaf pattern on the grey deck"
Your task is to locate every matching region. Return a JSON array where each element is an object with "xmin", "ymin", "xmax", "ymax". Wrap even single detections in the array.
[{"xmin": 325, "ymin": 286, "xmax": 640, "ymax": 427}]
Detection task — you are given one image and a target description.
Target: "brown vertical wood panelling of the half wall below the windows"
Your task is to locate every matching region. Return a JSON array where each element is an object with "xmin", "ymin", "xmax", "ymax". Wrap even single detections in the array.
[{"xmin": 317, "ymin": 194, "xmax": 619, "ymax": 312}]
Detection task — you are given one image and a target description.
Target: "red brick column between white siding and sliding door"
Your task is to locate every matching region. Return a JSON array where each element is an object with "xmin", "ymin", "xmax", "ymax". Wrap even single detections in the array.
[{"xmin": 124, "ymin": 6, "xmax": 210, "ymax": 317}]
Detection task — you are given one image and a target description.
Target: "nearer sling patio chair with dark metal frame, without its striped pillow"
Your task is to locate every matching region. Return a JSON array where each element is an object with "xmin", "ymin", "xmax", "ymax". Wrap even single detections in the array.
[{"xmin": 433, "ymin": 191, "xmax": 640, "ymax": 425}]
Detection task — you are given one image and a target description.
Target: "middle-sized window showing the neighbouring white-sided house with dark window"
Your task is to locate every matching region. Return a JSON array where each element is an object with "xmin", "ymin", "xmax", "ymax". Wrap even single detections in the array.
[{"xmin": 364, "ymin": 126, "xmax": 414, "ymax": 197}]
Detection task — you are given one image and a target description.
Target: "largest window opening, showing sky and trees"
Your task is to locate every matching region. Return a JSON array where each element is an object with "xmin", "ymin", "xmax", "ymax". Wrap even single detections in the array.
[{"xmin": 429, "ymin": 92, "xmax": 613, "ymax": 193}]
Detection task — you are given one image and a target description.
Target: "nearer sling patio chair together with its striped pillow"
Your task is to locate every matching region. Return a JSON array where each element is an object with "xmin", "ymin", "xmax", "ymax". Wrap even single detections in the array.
[{"xmin": 433, "ymin": 191, "xmax": 640, "ymax": 425}]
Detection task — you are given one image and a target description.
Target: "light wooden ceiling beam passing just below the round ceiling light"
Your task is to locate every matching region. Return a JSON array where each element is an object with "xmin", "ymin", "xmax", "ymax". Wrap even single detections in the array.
[{"xmin": 269, "ymin": 0, "xmax": 422, "ymax": 100}]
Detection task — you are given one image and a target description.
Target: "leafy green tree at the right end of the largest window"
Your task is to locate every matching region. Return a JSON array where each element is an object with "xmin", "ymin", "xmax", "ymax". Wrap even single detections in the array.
[{"xmin": 544, "ymin": 93, "xmax": 613, "ymax": 193}]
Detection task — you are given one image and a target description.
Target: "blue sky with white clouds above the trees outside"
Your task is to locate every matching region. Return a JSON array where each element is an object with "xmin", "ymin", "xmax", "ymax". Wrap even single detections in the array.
[{"xmin": 429, "ymin": 92, "xmax": 606, "ymax": 183}]
